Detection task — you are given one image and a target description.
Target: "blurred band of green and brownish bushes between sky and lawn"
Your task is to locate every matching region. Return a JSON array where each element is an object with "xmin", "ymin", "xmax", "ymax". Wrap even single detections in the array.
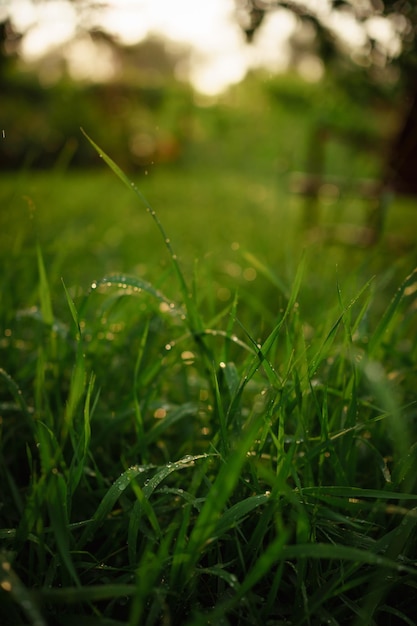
[{"xmin": 0, "ymin": 58, "xmax": 398, "ymax": 175}]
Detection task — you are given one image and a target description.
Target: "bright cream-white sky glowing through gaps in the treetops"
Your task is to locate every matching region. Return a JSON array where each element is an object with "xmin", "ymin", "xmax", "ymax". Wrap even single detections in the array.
[{"xmin": 6, "ymin": 0, "xmax": 402, "ymax": 95}]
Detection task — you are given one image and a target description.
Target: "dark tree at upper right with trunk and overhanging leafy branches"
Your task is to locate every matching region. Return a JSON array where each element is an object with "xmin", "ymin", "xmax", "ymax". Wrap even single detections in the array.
[{"xmin": 235, "ymin": 0, "xmax": 417, "ymax": 195}]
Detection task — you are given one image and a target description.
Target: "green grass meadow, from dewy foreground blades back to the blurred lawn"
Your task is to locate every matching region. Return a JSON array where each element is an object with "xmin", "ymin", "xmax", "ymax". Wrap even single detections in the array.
[{"xmin": 0, "ymin": 75, "xmax": 417, "ymax": 626}]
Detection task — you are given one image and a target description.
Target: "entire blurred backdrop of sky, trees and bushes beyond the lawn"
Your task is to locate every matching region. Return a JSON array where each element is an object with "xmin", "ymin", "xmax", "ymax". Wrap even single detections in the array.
[{"xmin": 0, "ymin": 0, "xmax": 417, "ymax": 176}]
